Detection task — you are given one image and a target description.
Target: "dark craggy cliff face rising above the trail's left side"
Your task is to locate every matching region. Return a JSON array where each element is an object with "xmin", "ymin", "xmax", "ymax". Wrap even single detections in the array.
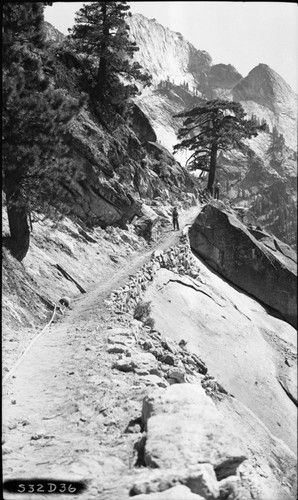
[{"xmin": 41, "ymin": 23, "xmax": 196, "ymax": 228}]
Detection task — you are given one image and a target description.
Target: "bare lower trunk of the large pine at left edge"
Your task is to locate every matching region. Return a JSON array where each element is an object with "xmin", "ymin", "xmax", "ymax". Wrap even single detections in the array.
[{"xmin": 6, "ymin": 189, "xmax": 30, "ymax": 261}]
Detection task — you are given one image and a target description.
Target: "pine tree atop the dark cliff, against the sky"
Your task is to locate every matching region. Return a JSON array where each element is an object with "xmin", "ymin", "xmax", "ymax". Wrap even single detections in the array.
[{"xmin": 69, "ymin": 2, "xmax": 150, "ymax": 107}]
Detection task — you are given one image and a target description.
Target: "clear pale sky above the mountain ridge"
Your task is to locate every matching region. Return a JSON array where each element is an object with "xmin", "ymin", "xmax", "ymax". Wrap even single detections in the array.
[{"xmin": 45, "ymin": 1, "xmax": 298, "ymax": 92}]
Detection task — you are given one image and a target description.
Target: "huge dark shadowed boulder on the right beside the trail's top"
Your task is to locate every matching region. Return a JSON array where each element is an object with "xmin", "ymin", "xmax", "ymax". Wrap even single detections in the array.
[{"xmin": 189, "ymin": 204, "xmax": 297, "ymax": 327}]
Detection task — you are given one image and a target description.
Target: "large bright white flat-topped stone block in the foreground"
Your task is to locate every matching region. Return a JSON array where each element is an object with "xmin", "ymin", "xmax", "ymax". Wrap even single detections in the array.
[{"xmin": 142, "ymin": 384, "xmax": 247, "ymax": 468}]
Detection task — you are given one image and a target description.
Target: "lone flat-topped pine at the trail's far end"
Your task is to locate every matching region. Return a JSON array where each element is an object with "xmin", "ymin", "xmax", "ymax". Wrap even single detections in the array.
[{"xmin": 174, "ymin": 100, "xmax": 263, "ymax": 194}]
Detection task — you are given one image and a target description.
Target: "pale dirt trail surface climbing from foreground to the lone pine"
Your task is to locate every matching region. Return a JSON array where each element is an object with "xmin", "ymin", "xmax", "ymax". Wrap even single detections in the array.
[{"xmin": 3, "ymin": 207, "xmax": 201, "ymax": 500}]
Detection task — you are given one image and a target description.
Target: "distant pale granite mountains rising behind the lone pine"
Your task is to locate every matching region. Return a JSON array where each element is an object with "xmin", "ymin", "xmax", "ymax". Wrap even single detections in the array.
[{"xmin": 129, "ymin": 14, "xmax": 297, "ymax": 247}]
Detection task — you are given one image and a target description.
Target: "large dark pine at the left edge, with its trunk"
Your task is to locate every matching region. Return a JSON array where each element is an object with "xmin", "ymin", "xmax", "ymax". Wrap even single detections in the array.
[{"xmin": 2, "ymin": 2, "xmax": 79, "ymax": 260}]
